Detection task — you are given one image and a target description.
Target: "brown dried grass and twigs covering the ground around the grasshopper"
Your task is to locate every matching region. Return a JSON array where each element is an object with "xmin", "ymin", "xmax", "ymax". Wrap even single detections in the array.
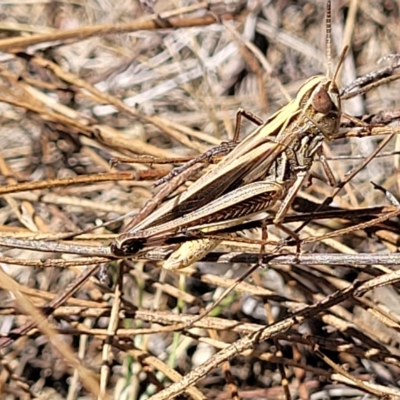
[{"xmin": 0, "ymin": 0, "xmax": 400, "ymax": 400}]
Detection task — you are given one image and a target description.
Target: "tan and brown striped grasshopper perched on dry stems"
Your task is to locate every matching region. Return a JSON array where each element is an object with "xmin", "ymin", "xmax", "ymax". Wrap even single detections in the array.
[{"xmin": 111, "ymin": 1, "xmax": 345, "ymax": 269}]
